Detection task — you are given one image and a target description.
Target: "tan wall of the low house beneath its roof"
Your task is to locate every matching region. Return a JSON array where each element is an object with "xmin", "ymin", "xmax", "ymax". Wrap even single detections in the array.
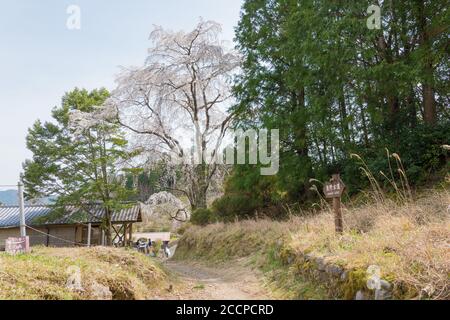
[{"xmin": 0, "ymin": 226, "xmax": 82, "ymax": 251}]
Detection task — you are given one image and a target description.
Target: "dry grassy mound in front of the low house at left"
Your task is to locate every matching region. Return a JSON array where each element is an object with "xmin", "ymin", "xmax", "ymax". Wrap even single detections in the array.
[{"xmin": 0, "ymin": 247, "xmax": 166, "ymax": 299}]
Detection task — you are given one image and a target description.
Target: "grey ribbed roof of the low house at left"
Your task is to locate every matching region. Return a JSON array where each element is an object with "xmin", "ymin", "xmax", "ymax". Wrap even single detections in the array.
[{"xmin": 0, "ymin": 204, "xmax": 142, "ymax": 229}]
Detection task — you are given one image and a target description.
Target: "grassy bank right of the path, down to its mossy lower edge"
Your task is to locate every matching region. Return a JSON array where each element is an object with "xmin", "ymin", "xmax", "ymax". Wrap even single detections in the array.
[{"xmin": 176, "ymin": 191, "xmax": 450, "ymax": 299}]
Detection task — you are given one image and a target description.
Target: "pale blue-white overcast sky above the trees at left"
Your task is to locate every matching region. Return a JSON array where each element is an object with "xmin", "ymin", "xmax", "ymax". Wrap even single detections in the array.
[{"xmin": 0, "ymin": 0, "xmax": 242, "ymax": 186}]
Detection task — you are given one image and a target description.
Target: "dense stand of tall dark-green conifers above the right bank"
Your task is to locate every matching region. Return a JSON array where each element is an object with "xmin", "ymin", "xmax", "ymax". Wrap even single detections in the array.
[{"xmin": 207, "ymin": 0, "xmax": 450, "ymax": 220}]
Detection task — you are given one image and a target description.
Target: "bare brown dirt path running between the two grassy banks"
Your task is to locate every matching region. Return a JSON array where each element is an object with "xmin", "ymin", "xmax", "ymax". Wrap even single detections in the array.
[{"xmin": 164, "ymin": 260, "xmax": 271, "ymax": 300}]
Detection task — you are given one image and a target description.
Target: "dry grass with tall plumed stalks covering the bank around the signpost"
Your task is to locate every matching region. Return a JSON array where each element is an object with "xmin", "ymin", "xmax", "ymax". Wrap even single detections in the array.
[{"xmin": 180, "ymin": 150, "xmax": 450, "ymax": 299}]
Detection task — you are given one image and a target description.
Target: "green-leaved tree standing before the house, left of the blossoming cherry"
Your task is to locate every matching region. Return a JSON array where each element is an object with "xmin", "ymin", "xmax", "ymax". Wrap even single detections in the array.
[{"xmin": 23, "ymin": 89, "xmax": 132, "ymax": 245}]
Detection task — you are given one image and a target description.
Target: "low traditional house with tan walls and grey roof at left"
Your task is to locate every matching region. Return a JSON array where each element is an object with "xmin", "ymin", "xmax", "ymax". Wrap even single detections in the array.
[{"xmin": 0, "ymin": 205, "xmax": 142, "ymax": 250}]
